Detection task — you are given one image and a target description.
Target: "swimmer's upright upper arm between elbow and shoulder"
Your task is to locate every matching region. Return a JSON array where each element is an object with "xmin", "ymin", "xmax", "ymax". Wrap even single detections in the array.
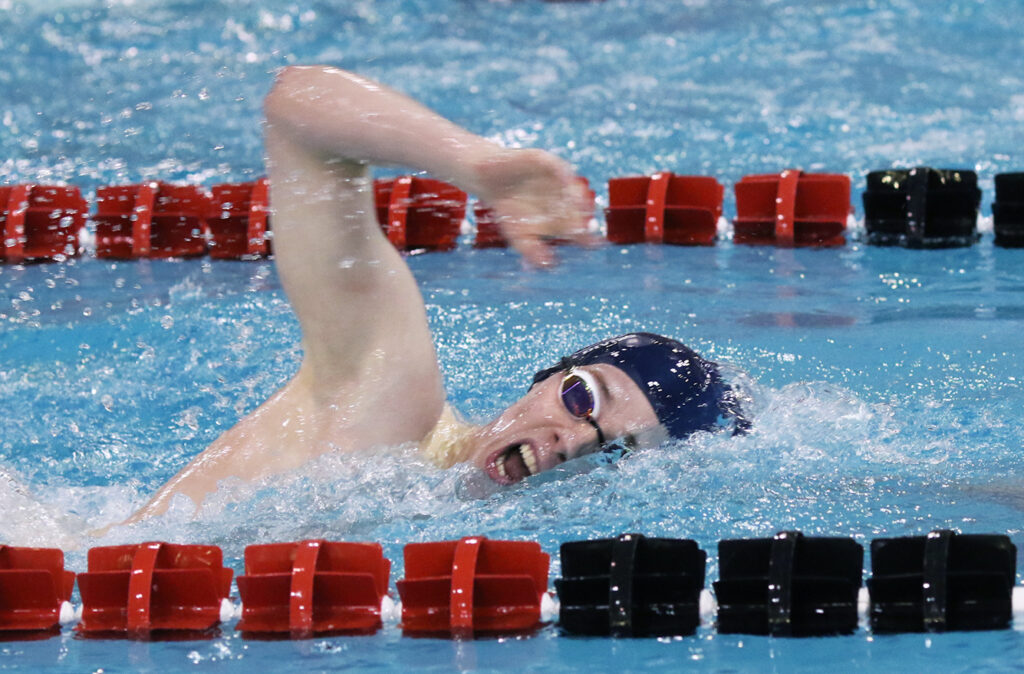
[{"xmin": 265, "ymin": 70, "xmax": 443, "ymax": 416}]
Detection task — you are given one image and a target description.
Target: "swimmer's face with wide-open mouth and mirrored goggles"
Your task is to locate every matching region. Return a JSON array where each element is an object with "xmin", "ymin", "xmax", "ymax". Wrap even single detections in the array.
[{"xmin": 470, "ymin": 364, "xmax": 668, "ymax": 485}]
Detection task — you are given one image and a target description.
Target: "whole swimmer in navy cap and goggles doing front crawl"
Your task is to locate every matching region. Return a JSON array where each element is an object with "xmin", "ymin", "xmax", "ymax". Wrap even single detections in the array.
[{"xmin": 132, "ymin": 67, "xmax": 741, "ymax": 520}]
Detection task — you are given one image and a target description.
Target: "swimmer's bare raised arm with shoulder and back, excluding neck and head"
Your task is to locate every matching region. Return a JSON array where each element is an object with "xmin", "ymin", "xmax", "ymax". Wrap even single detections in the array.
[{"xmin": 130, "ymin": 67, "xmax": 587, "ymax": 521}]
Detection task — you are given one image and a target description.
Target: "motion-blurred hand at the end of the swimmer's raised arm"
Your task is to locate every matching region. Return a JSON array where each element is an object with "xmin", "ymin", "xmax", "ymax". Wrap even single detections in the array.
[{"xmin": 476, "ymin": 150, "xmax": 597, "ymax": 266}]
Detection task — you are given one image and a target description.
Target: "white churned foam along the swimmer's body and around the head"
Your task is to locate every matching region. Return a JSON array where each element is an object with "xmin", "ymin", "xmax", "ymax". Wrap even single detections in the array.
[{"xmin": 0, "ymin": 370, "xmax": 922, "ymax": 558}]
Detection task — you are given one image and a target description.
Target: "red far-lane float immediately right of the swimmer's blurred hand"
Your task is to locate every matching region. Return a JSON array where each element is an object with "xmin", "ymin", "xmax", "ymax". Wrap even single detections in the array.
[{"xmin": 604, "ymin": 171, "xmax": 725, "ymax": 246}]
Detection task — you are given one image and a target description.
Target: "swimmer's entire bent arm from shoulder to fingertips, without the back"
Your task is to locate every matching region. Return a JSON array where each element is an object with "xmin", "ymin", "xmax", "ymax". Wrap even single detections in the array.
[{"xmin": 265, "ymin": 67, "xmax": 586, "ymax": 389}]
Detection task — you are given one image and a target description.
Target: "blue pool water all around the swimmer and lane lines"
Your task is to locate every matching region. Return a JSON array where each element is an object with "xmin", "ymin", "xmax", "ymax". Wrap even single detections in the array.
[{"xmin": 0, "ymin": 0, "xmax": 1024, "ymax": 672}]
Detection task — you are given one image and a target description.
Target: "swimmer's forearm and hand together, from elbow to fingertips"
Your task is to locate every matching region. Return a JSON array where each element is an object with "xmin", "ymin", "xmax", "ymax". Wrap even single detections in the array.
[{"xmin": 265, "ymin": 66, "xmax": 592, "ymax": 265}]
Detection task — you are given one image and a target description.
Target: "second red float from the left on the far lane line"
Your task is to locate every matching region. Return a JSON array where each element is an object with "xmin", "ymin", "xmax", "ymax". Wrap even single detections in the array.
[{"xmin": 92, "ymin": 182, "xmax": 210, "ymax": 259}]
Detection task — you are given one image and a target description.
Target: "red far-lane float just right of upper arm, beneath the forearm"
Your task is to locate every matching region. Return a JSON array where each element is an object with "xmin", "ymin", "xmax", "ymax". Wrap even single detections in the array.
[{"xmin": 374, "ymin": 175, "xmax": 466, "ymax": 251}]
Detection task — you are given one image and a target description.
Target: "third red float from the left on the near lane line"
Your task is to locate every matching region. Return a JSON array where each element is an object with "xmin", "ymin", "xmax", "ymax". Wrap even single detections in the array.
[{"xmin": 238, "ymin": 541, "xmax": 391, "ymax": 639}]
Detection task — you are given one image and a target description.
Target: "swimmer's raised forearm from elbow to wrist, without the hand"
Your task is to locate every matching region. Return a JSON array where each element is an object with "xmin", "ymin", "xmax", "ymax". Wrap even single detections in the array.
[{"xmin": 265, "ymin": 66, "xmax": 502, "ymax": 193}]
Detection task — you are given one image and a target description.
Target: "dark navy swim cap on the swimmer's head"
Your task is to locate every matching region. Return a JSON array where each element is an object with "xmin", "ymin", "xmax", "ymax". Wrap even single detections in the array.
[{"xmin": 534, "ymin": 332, "xmax": 750, "ymax": 438}]
